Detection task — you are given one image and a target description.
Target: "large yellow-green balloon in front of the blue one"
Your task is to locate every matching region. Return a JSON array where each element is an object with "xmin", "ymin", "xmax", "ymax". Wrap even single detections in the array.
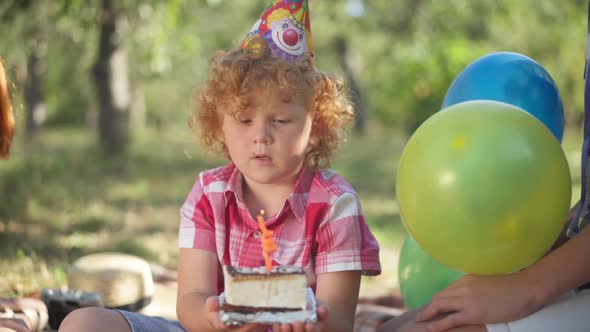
[{"xmin": 396, "ymin": 100, "xmax": 571, "ymax": 274}]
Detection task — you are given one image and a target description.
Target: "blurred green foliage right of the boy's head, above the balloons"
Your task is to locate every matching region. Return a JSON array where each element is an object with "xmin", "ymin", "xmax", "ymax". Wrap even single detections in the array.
[{"xmin": 330, "ymin": 0, "xmax": 586, "ymax": 134}]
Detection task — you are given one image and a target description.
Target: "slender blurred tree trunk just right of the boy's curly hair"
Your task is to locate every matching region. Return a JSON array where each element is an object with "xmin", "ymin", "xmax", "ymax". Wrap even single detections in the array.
[{"xmin": 336, "ymin": 38, "xmax": 367, "ymax": 135}]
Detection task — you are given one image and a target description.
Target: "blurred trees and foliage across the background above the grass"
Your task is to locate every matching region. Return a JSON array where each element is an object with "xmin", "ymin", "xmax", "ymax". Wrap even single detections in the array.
[{"xmin": 0, "ymin": 0, "xmax": 586, "ymax": 145}]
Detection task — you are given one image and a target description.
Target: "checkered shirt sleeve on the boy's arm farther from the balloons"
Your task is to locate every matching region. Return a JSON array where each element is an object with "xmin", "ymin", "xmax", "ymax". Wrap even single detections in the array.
[{"xmin": 178, "ymin": 176, "xmax": 220, "ymax": 252}]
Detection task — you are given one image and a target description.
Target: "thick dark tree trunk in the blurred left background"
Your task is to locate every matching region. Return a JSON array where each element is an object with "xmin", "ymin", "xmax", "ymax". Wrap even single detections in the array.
[{"xmin": 93, "ymin": 0, "xmax": 131, "ymax": 154}]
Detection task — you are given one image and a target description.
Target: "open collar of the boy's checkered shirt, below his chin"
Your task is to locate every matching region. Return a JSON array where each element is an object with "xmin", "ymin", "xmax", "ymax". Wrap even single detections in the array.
[{"xmin": 224, "ymin": 165, "xmax": 315, "ymax": 222}]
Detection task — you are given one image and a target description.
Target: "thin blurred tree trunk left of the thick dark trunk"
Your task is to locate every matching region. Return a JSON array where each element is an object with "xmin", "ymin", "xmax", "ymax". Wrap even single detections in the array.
[{"xmin": 25, "ymin": 47, "xmax": 47, "ymax": 136}]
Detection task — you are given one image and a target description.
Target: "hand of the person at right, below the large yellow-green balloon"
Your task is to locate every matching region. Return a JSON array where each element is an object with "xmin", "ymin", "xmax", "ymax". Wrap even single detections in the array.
[{"xmin": 416, "ymin": 272, "xmax": 538, "ymax": 332}]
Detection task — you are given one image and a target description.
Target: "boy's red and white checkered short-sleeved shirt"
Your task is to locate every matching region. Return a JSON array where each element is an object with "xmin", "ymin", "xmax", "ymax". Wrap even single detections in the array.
[{"xmin": 178, "ymin": 163, "xmax": 381, "ymax": 292}]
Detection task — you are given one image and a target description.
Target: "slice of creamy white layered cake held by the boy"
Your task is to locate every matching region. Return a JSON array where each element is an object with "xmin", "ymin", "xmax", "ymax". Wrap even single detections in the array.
[{"xmin": 221, "ymin": 266, "xmax": 315, "ymax": 323}]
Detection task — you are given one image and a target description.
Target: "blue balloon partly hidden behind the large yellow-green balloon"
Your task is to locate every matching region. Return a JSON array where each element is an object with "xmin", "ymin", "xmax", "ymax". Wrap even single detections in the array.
[{"xmin": 442, "ymin": 52, "xmax": 565, "ymax": 142}]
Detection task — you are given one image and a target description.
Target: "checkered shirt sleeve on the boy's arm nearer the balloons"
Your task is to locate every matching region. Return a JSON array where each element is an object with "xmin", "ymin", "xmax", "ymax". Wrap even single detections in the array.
[{"xmin": 315, "ymin": 192, "xmax": 381, "ymax": 275}]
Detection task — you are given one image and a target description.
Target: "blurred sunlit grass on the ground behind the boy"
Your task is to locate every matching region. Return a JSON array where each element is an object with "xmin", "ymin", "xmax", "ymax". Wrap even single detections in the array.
[{"xmin": 0, "ymin": 126, "xmax": 581, "ymax": 296}]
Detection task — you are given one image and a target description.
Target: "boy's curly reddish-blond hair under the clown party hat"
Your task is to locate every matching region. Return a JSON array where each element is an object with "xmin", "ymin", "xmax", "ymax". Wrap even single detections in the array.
[{"xmin": 189, "ymin": 39, "xmax": 354, "ymax": 168}]
